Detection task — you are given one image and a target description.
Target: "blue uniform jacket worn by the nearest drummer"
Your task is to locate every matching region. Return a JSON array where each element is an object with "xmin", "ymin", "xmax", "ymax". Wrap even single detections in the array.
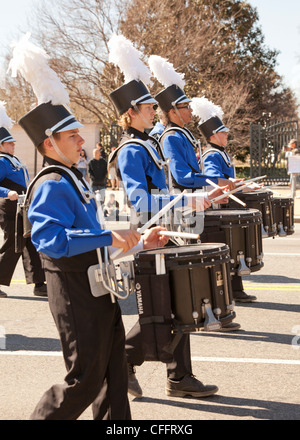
[{"xmin": 28, "ymin": 161, "xmax": 112, "ymax": 258}]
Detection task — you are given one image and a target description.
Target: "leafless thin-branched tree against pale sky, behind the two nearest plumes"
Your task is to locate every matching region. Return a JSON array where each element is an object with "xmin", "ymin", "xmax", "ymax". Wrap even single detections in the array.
[{"xmin": 2, "ymin": 0, "xmax": 122, "ymax": 126}]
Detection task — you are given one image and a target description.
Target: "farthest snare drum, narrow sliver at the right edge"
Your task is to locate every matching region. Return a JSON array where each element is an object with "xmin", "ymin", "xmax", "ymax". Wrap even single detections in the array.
[{"xmin": 273, "ymin": 197, "xmax": 295, "ymax": 237}]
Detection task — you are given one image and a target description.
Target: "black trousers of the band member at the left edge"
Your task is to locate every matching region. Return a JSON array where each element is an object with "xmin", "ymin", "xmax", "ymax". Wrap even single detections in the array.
[{"xmin": 0, "ymin": 216, "xmax": 45, "ymax": 286}]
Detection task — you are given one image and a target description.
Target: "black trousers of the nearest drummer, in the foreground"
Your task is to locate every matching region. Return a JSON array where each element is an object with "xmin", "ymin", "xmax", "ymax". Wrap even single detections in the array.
[{"xmin": 31, "ymin": 269, "xmax": 131, "ymax": 420}]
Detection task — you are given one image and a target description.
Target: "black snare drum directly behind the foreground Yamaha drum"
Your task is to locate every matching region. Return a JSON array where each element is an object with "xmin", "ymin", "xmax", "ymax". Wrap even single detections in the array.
[{"xmin": 201, "ymin": 209, "xmax": 264, "ymax": 276}]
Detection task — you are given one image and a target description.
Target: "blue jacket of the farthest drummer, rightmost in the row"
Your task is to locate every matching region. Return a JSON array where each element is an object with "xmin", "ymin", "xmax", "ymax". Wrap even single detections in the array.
[{"xmin": 203, "ymin": 145, "xmax": 235, "ymax": 179}]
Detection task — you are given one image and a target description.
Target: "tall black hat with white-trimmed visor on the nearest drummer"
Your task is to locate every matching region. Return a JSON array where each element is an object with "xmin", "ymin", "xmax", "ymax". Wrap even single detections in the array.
[{"xmin": 19, "ymin": 102, "xmax": 83, "ymax": 147}]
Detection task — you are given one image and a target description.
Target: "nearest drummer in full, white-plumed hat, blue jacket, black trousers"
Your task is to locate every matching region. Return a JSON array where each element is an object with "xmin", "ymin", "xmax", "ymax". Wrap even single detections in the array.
[{"xmin": 10, "ymin": 36, "xmax": 166, "ymax": 420}]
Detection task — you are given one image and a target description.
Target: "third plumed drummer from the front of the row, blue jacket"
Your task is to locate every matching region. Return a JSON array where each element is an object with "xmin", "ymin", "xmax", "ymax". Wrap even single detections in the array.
[{"xmin": 149, "ymin": 55, "xmax": 240, "ymax": 331}]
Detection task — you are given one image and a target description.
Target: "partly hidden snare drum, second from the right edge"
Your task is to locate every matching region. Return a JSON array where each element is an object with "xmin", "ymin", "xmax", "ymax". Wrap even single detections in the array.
[{"xmin": 228, "ymin": 190, "xmax": 277, "ymax": 238}]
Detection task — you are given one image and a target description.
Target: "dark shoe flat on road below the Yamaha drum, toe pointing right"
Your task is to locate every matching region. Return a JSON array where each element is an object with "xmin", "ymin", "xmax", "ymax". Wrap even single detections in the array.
[{"xmin": 166, "ymin": 374, "xmax": 219, "ymax": 397}]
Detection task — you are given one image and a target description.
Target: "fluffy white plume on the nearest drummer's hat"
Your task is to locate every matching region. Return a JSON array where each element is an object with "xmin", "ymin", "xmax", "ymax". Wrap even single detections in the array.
[{"xmin": 8, "ymin": 33, "xmax": 70, "ymax": 106}]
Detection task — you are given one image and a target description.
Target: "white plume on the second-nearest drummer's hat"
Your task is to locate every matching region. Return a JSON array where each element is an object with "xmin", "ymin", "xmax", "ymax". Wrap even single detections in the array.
[{"xmin": 108, "ymin": 34, "xmax": 152, "ymax": 85}]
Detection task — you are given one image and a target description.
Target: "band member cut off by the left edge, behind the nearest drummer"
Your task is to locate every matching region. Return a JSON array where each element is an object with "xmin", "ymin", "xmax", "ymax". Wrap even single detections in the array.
[{"xmin": 0, "ymin": 102, "xmax": 47, "ymax": 298}]
